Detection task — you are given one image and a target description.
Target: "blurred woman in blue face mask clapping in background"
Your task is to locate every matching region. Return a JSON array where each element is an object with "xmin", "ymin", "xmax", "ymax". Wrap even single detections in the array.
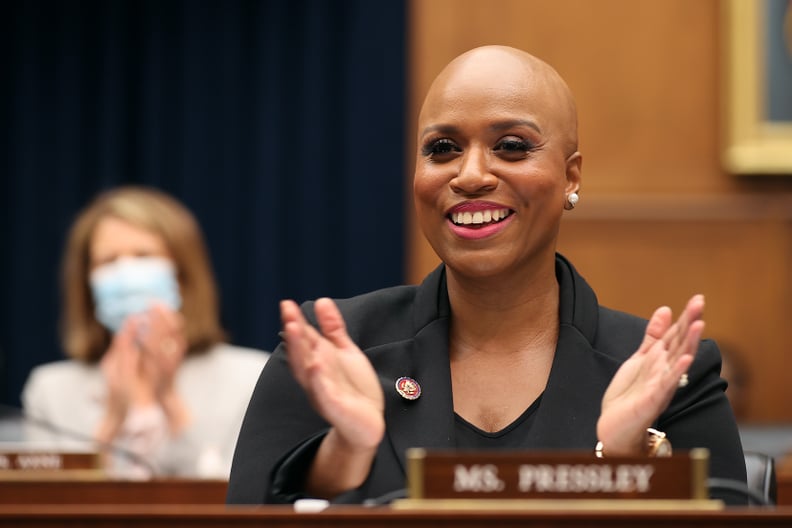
[{"xmin": 22, "ymin": 186, "xmax": 269, "ymax": 478}]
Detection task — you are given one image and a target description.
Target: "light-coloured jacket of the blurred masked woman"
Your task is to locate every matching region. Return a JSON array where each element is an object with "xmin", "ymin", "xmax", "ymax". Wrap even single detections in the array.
[{"xmin": 22, "ymin": 343, "xmax": 269, "ymax": 479}]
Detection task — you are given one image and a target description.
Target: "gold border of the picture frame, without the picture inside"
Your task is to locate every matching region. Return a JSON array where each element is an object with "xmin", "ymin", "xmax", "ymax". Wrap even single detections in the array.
[{"xmin": 723, "ymin": 0, "xmax": 792, "ymax": 175}]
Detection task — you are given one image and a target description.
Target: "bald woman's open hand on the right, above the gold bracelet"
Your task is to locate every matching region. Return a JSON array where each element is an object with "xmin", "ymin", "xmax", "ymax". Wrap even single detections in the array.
[{"xmin": 597, "ymin": 295, "xmax": 704, "ymax": 456}]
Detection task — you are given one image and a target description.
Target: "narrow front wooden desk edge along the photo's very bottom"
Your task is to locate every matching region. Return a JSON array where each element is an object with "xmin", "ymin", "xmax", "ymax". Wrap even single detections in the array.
[{"xmin": 0, "ymin": 505, "xmax": 792, "ymax": 528}]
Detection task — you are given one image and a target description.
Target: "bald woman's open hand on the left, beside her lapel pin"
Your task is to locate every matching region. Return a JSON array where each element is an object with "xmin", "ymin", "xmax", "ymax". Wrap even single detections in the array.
[{"xmin": 281, "ymin": 298, "xmax": 385, "ymax": 498}]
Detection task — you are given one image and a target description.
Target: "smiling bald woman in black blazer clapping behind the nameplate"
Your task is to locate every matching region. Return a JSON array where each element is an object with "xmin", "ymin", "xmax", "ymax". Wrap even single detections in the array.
[{"xmin": 228, "ymin": 46, "xmax": 746, "ymax": 504}]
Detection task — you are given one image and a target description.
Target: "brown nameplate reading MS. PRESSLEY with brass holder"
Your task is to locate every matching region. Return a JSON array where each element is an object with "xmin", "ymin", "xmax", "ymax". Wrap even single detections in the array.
[{"xmin": 393, "ymin": 449, "xmax": 723, "ymax": 510}]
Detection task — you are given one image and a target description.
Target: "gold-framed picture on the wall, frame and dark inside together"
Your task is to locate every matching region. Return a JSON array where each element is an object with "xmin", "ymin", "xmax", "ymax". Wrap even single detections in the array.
[{"xmin": 723, "ymin": 0, "xmax": 792, "ymax": 175}]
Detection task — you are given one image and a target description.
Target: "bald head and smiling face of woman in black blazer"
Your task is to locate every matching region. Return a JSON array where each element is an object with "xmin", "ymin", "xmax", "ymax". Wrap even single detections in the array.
[{"xmin": 413, "ymin": 50, "xmax": 581, "ymax": 275}]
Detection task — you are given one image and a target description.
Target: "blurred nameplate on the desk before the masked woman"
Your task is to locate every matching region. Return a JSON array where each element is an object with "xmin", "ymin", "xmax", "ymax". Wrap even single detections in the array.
[{"xmin": 0, "ymin": 449, "xmax": 105, "ymax": 480}]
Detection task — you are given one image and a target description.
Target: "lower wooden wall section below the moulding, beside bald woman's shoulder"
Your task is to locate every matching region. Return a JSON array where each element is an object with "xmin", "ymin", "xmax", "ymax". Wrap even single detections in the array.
[{"xmin": 559, "ymin": 196, "xmax": 792, "ymax": 422}]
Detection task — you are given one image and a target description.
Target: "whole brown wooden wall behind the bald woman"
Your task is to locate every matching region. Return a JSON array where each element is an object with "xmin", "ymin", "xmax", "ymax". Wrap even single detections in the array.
[{"xmin": 406, "ymin": 0, "xmax": 792, "ymax": 423}]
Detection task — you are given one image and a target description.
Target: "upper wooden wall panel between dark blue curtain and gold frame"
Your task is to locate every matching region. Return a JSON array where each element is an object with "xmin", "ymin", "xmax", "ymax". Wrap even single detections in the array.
[{"xmin": 411, "ymin": 0, "xmax": 730, "ymax": 193}]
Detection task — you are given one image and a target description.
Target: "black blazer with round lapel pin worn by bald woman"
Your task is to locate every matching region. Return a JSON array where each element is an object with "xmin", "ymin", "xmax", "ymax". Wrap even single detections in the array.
[{"xmin": 227, "ymin": 255, "xmax": 746, "ymax": 504}]
